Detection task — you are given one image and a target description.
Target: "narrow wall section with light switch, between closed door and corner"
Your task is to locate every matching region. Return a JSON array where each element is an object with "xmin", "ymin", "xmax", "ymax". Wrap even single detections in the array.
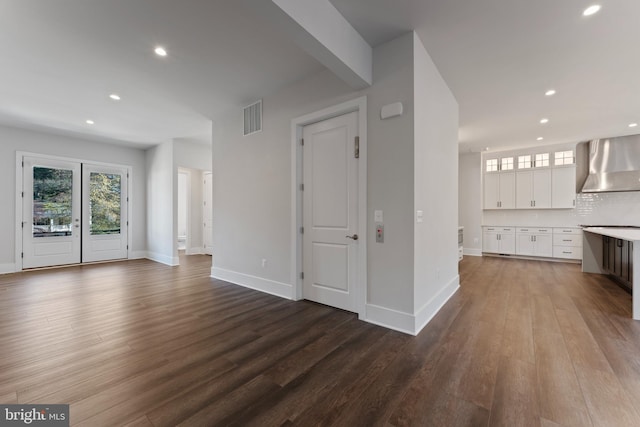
[{"xmin": 367, "ymin": 33, "xmax": 414, "ymax": 314}]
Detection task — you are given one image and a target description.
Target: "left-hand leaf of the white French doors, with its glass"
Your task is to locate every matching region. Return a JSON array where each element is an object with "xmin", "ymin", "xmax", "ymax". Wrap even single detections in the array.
[{"xmin": 22, "ymin": 156, "xmax": 81, "ymax": 268}]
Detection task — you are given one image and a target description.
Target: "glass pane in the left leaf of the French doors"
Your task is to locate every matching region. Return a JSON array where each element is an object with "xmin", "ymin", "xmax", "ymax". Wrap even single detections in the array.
[{"xmin": 33, "ymin": 166, "xmax": 73, "ymax": 237}]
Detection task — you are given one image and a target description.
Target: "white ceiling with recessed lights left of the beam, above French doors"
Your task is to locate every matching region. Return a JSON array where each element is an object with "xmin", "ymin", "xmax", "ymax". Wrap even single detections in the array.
[{"xmin": 0, "ymin": 0, "xmax": 321, "ymax": 147}]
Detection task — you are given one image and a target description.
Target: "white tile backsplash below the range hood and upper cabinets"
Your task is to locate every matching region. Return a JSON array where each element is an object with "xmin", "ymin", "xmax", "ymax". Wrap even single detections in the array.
[{"xmin": 482, "ymin": 191, "xmax": 640, "ymax": 227}]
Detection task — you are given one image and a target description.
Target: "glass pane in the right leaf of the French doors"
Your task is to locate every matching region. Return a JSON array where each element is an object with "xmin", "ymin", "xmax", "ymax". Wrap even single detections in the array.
[{"xmin": 89, "ymin": 172, "xmax": 122, "ymax": 235}]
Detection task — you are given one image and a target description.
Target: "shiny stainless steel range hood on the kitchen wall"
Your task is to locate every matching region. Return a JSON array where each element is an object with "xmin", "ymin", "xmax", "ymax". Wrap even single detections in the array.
[{"xmin": 582, "ymin": 135, "xmax": 640, "ymax": 193}]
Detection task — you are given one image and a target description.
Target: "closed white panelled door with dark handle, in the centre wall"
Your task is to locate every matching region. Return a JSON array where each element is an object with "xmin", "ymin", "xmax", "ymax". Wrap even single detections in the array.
[{"xmin": 303, "ymin": 112, "xmax": 359, "ymax": 312}]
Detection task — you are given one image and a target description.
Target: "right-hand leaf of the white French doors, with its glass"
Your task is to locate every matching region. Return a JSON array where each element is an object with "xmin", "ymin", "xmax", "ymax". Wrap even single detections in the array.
[{"xmin": 82, "ymin": 163, "xmax": 128, "ymax": 262}]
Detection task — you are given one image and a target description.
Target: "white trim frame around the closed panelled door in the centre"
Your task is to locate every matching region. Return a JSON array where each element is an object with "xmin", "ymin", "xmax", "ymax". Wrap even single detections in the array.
[{"xmin": 291, "ymin": 96, "xmax": 367, "ymax": 319}]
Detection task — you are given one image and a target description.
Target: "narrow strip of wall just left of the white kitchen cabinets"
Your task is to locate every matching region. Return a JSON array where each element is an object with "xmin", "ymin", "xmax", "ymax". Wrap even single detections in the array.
[{"xmin": 458, "ymin": 153, "xmax": 482, "ymax": 255}]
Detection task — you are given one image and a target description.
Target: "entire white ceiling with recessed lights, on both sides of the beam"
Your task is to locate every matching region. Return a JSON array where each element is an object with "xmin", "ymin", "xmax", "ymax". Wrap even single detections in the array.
[{"xmin": 0, "ymin": 0, "xmax": 640, "ymax": 151}]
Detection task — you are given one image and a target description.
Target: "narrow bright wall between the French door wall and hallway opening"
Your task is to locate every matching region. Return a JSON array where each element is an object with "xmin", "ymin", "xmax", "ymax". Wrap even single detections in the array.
[{"xmin": 146, "ymin": 141, "xmax": 179, "ymax": 265}]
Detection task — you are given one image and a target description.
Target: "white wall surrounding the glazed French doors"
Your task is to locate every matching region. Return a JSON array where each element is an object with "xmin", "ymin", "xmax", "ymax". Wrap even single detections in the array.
[{"xmin": 0, "ymin": 126, "xmax": 146, "ymax": 272}]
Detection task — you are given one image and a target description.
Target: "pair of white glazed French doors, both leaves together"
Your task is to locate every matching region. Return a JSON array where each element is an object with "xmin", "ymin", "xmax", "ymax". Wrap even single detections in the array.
[{"xmin": 22, "ymin": 156, "xmax": 128, "ymax": 268}]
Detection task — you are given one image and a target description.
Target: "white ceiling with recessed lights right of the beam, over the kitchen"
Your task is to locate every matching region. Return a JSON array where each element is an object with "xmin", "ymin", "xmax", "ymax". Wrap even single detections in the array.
[{"xmin": 332, "ymin": 0, "xmax": 640, "ymax": 151}]
